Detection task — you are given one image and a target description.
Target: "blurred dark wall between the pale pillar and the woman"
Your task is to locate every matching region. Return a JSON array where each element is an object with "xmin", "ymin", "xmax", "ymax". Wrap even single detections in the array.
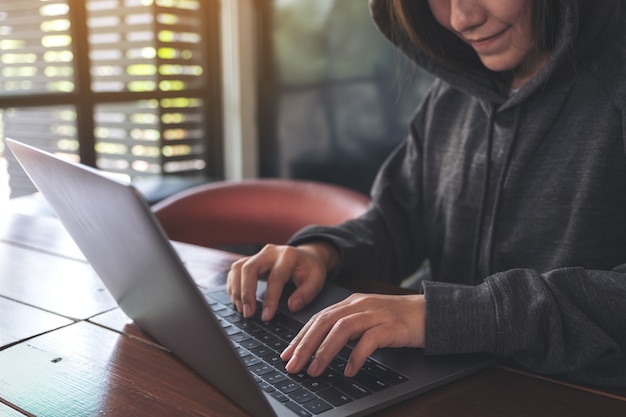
[{"xmin": 260, "ymin": 0, "xmax": 431, "ymax": 192}]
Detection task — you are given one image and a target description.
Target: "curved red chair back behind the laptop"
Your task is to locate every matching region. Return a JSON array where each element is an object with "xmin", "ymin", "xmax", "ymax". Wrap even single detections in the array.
[{"xmin": 153, "ymin": 178, "xmax": 369, "ymax": 253}]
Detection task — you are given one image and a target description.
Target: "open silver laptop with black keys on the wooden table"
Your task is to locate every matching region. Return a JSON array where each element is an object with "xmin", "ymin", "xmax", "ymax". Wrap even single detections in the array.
[{"xmin": 6, "ymin": 139, "xmax": 492, "ymax": 417}]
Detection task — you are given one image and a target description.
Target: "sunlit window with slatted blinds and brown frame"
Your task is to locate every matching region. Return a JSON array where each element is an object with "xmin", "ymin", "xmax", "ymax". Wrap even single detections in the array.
[{"xmin": 0, "ymin": 0, "xmax": 221, "ymax": 197}]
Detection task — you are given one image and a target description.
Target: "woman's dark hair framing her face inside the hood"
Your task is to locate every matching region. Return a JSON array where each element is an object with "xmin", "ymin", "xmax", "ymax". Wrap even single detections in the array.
[{"xmin": 388, "ymin": 0, "xmax": 561, "ymax": 91}]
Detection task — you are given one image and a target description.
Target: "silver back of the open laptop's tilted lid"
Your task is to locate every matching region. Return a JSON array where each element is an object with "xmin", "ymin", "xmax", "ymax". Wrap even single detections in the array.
[{"xmin": 6, "ymin": 139, "xmax": 275, "ymax": 416}]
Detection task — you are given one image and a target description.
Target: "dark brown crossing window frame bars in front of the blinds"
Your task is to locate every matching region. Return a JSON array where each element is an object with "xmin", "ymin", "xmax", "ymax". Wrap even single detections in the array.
[{"xmin": 0, "ymin": 0, "xmax": 224, "ymax": 179}]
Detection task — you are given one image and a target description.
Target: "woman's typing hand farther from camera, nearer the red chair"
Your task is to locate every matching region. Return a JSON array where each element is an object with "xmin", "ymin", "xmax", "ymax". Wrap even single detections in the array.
[{"xmin": 227, "ymin": 242, "xmax": 339, "ymax": 321}]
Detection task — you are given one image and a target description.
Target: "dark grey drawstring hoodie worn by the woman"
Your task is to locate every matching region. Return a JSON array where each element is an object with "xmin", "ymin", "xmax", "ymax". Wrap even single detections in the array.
[{"xmin": 290, "ymin": 0, "xmax": 626, "ymax": 387}]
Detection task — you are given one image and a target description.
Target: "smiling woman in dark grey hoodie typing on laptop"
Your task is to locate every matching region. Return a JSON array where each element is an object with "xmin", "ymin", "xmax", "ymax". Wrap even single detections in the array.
[{"xmin": 228, "ymin": 0, "xmax": 626, "ymax": 387}]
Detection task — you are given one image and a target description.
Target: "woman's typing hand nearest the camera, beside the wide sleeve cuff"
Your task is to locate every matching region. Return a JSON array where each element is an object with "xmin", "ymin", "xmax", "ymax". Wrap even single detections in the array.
[{"xmin": 281, "ymin": 294, "xmax": 425, "ymax": 377}]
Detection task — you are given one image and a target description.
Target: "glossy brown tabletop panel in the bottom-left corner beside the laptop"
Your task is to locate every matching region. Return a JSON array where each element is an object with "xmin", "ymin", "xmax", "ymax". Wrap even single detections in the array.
[{"xmin": 0, "ymin": 322, "xmax": 246, "ymax": 417}]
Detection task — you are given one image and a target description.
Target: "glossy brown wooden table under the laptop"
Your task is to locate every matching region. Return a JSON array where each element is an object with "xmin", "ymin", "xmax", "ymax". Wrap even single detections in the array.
[{"xmin": 0, "ymin": 213, "xmax": 626, "ymax": 417}]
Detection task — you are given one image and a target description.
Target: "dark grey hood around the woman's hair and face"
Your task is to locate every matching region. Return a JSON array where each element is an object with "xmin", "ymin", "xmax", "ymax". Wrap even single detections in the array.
[{"xmin": 369, "ymin": 0, "xmax": 608, "ymax": 105}]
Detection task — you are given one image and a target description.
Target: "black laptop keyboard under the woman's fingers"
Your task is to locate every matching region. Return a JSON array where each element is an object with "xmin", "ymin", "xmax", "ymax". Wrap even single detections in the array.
[{"xmin": 205, "ymin": 291, "xmax": 408, "ymax": 417}]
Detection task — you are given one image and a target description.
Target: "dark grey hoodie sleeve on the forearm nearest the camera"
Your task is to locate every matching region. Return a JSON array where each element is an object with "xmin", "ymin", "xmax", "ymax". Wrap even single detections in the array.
[{"xmin": 424, "ymin": 265, "xmax": 626, "ymax": 388}]
